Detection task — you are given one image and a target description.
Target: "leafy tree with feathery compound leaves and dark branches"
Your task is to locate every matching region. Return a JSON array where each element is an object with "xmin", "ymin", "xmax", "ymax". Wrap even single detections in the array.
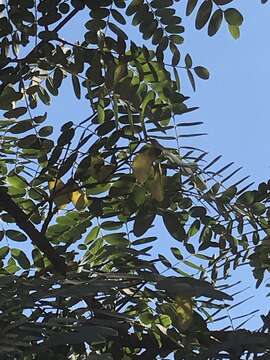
[{"xmin": 0, "ymin": 0, "xmax": 270, "ymax": 360}]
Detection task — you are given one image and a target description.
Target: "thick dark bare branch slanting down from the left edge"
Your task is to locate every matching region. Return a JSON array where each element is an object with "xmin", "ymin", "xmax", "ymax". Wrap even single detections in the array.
[{"xmin": 0, "ymin": 187, "xmax": 67, "ymax": 275}]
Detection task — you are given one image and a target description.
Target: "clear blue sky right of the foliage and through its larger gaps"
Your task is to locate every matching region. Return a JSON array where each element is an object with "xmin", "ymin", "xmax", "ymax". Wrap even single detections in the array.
[{"xmin": 40, "ymin": 0, "xmax": 270, "ymax": 328}]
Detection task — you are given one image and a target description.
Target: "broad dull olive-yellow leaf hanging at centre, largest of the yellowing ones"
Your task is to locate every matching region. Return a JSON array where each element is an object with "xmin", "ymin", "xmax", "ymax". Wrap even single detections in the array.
[{"xmin": 132, "ymin": 148, "xmax": 160, "ymax": 184}]
